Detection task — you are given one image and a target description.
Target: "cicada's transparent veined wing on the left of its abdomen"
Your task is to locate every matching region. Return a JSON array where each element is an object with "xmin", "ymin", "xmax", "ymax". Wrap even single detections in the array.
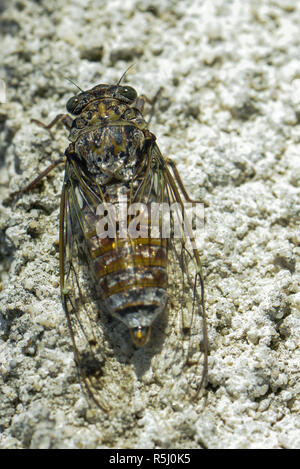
[{"xmin": 60, "ymin": 162, "xmax": 109, "ymax": 410}]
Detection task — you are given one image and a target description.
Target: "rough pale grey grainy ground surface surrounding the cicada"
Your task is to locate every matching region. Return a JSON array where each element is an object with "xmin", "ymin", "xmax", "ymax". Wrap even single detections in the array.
[{"xmin": 0, "ymin": 0, "xmax": 300, "ymax": 448}]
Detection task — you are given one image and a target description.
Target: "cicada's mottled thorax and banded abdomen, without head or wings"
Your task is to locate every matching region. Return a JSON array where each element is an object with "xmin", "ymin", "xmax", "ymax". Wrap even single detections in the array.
[{"xmin": 67, "ymin": 95, "xmax": 168, "ymax": 346}]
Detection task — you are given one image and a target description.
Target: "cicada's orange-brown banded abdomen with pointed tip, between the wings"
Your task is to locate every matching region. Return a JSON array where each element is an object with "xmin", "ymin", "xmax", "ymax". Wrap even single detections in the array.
[{"xmin": 88, "ymin": 191, "xmax": 168, "ymax": 346}]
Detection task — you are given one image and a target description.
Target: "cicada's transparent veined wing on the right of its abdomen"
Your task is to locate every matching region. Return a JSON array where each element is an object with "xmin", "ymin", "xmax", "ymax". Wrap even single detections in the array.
[{"xmin": 146, "ymin": 145, "xmax": 208, "ymax": 397}]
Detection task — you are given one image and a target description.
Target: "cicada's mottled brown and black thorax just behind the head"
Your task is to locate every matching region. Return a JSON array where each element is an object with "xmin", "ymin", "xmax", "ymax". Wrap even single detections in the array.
[{"xmin": 69, "ymin": 99, "xmax": 149, "ymax": 186}]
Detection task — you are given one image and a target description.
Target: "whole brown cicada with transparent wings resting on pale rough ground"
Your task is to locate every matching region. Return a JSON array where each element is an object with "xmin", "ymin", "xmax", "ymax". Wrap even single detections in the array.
[{"xmin": 13, "ymin": 70, "xmax": 208, "ymax": 409}]
